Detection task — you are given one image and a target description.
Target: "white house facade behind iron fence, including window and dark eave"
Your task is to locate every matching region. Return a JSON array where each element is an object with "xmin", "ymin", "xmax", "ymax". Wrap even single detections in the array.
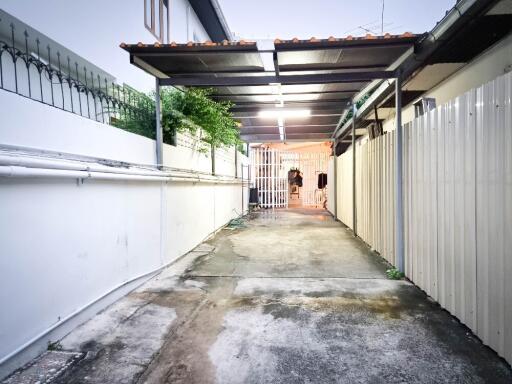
[{"xmin": 1, "ymin": 0, "xmax": 230, "ymax": 91}]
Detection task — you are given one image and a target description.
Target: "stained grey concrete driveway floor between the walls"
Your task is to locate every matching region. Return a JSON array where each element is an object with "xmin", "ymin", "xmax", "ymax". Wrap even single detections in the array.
[{"xmin": 7, "ymin": 210, "xmax": 512, "ymax": 383}]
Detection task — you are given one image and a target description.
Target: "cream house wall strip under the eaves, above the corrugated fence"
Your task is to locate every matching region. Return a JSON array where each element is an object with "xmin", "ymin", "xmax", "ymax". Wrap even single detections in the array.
[{"xmin": 383, "ymin": 34, "xmax": 512, "ymax": 131}]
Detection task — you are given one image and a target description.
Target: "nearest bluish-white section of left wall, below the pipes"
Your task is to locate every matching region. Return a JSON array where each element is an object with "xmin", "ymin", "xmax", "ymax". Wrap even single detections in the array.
[{"xmin": 0, "ymin": 178, "xmax": 163, "ymax": 364}]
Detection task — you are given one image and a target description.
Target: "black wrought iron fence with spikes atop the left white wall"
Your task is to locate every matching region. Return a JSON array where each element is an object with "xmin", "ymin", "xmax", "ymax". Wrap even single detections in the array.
[{"xmin": 0, "ymin": 19, "xmax": 155, "ymax": 138}]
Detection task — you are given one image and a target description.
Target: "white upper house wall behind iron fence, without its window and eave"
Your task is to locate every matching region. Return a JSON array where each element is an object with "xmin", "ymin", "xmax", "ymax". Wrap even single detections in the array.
[{"xmin": 1, "ymin": 0, "xmax": 209, "ymax": 92}]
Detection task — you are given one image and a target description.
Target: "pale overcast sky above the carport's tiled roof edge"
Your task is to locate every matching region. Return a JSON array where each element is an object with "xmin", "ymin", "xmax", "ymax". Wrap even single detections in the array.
[{"xmin": 218, "ymin": 0, "xmax": 455, "ymax": 39}]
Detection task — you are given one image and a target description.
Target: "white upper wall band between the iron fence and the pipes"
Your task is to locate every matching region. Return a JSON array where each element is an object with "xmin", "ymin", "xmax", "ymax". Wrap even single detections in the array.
[{"xmin": 0, "ymin": 90, "xmax": 156, "ymax": 164}]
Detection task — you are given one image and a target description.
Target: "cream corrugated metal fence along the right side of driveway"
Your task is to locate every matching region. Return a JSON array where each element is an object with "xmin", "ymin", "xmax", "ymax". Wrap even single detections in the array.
[{"xmin": 337, "ymin": 73, "xmax": 512, "ymax": 362}]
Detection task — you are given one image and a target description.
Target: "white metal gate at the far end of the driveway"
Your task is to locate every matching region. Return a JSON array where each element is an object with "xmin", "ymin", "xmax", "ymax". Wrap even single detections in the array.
[{"xmin": 250, "ymin": 148, "xmax": 329, "ymax": 208}]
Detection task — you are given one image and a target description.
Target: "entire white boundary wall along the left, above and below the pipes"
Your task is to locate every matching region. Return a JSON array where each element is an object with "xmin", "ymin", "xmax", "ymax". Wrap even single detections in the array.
[{"xmin": 0, "ymin": 90, "xmax": 247, "ymax": 377}]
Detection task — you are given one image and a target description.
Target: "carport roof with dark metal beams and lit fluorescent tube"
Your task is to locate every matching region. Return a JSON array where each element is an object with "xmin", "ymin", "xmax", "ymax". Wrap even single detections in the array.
[{"xmin": 121, "ymin": 33, "xmax": 422, "ymax": 141}]
